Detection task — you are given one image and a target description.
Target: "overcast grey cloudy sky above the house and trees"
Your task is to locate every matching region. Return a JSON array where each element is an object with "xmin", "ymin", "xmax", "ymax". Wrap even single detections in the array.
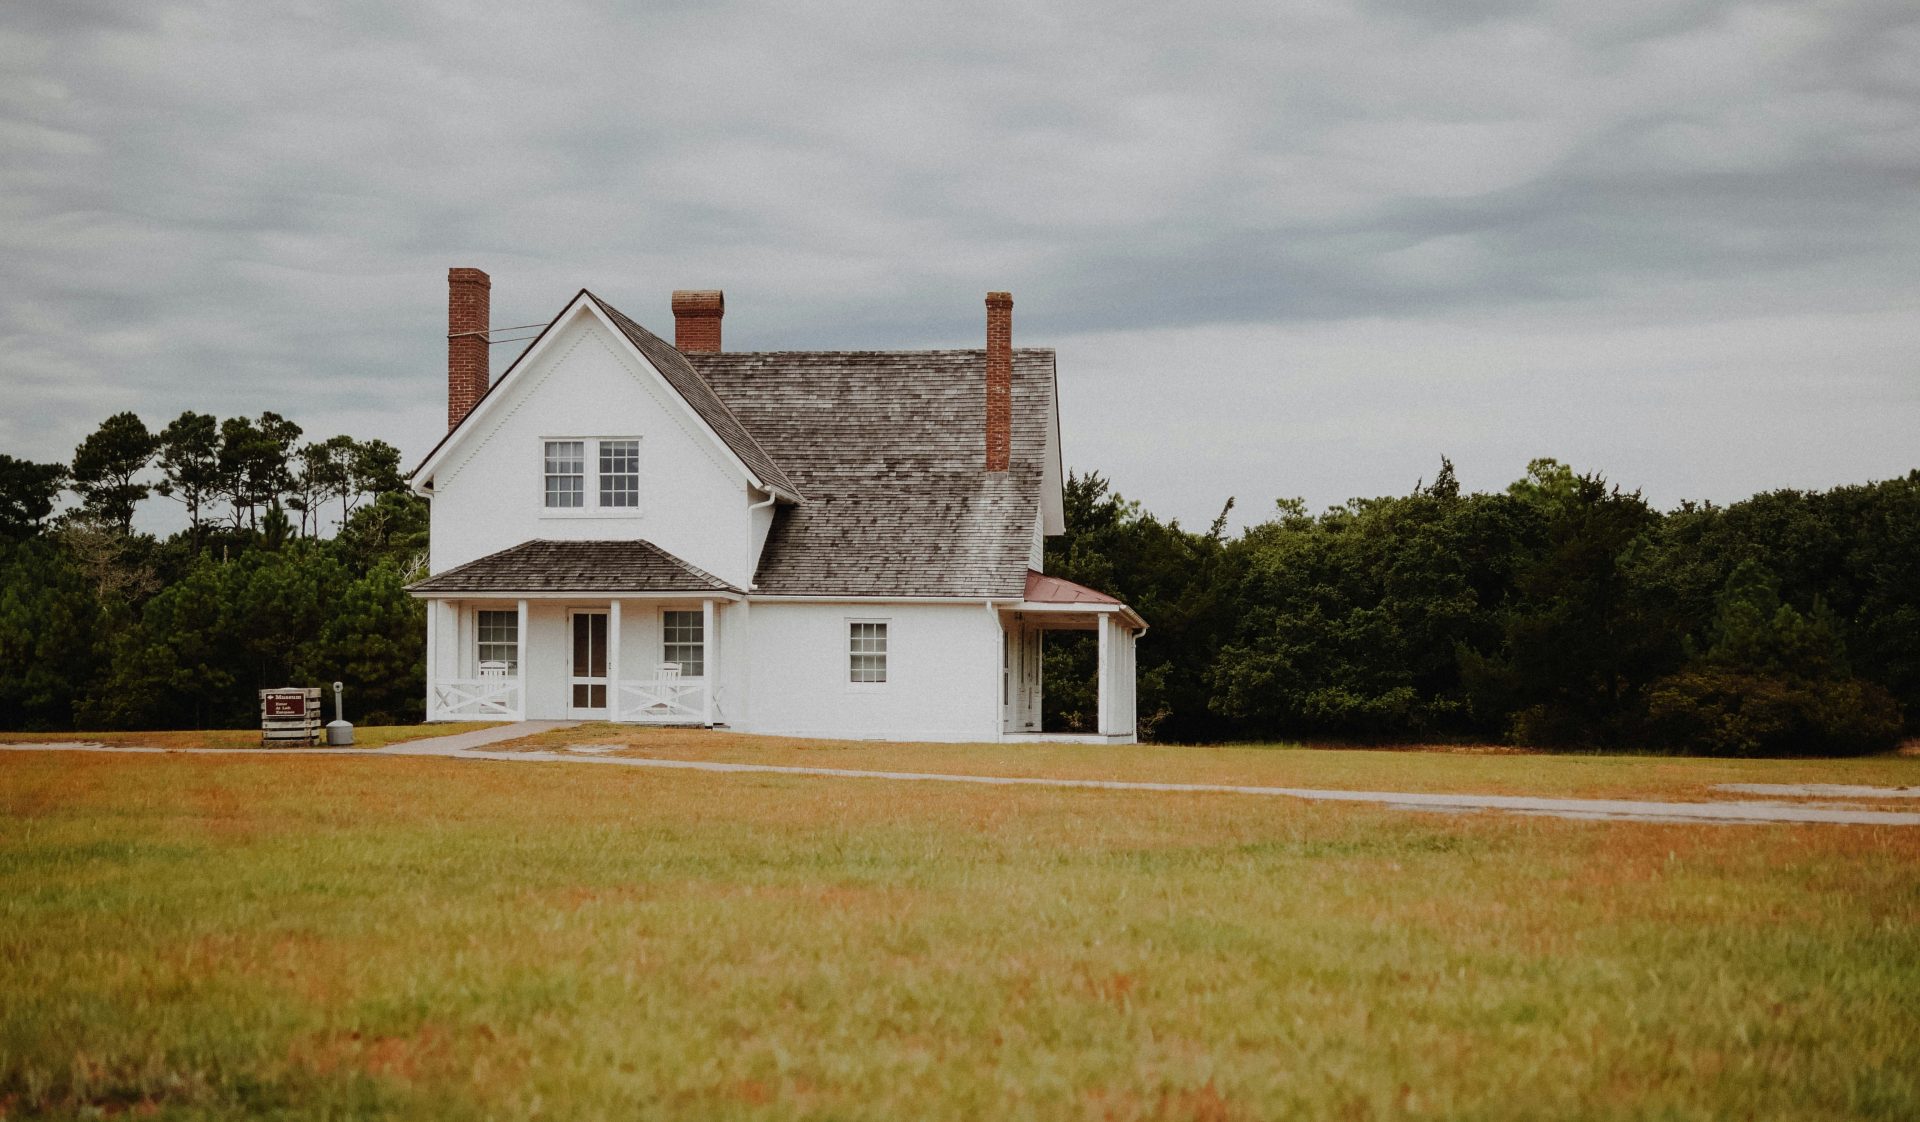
[{"xmin": 0, "ymin": 0, "xmax": 1920, "ymax": 523}]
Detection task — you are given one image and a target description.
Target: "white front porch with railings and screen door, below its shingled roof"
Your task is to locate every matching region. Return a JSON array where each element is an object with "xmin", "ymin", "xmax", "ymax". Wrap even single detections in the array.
[{"xmin": 426, "ymin": 594, "xmax": 732, "ymax": 726}]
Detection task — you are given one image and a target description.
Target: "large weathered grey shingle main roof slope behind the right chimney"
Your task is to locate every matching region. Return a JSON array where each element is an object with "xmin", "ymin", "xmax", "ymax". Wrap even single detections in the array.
[{"xmin": 685, "ymin": 348, "xmax": 1054, "ymax": 599}]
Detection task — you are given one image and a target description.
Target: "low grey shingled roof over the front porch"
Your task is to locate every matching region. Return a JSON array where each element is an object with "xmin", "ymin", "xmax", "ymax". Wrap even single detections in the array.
[{"xmin": 409, "ymin": 540, "xmax": 739, "ymax": 594}]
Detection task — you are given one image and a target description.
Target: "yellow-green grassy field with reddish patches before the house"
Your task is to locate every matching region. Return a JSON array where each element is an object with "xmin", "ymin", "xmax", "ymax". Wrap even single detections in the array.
[{"xmin": 0, "ymin": 730, "xmax": 1920, "ymax": 1120}]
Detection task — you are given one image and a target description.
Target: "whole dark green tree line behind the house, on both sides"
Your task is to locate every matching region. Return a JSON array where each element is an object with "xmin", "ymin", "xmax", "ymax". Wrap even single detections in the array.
[{"xmin": 0, "ymin": 413, "xmax": 1920, "ymax": 755}]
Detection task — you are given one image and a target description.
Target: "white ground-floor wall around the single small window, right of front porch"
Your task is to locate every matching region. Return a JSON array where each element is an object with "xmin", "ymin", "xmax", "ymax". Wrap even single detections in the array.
[{"xmin": 728, "ymin": 599, "xmax": 1000, "ymax": 742}]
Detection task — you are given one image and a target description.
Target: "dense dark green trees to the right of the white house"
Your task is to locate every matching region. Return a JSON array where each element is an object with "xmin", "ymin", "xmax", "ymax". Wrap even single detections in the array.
[{"xmin": 1046, "ymin": 459, "xmax": 1920, "ymax": 755}]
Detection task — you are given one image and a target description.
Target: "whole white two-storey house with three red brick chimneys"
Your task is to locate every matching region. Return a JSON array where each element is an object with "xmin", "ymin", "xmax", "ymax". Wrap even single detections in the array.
[{"xmin": 411, "ymin": 269, "xmax": 1146, "ymax": 742}]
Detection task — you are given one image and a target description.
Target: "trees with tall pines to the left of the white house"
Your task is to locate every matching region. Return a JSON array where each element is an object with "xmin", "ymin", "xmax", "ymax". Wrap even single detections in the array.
[{"xmin": 0, "ymin": 411, "xmax": 426, "ymax": 730}]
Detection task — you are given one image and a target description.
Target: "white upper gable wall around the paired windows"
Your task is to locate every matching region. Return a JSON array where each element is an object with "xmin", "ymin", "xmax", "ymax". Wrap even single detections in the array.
[{"xmin": 428, "ymin": 307, "xmax": 766, "ymax": 588}]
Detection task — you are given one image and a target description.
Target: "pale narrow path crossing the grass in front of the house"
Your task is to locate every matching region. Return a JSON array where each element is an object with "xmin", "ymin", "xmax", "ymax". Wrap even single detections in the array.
[{"xmin": 0, "ymin": 720, "xmax": 1920, "ymax": 826}]
